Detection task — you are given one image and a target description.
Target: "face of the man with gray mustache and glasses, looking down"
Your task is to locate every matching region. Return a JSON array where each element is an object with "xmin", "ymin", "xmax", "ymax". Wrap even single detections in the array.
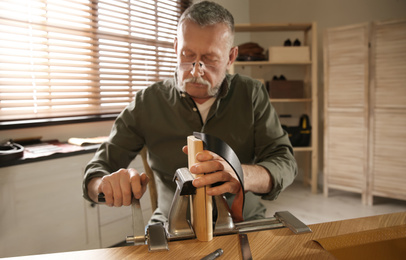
[{"xmin": 175, "ymin": 21, "xmax": 235, "ymax": 103}]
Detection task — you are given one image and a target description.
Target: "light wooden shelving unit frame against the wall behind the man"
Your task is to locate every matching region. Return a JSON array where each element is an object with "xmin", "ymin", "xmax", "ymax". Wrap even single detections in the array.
[{"xmin": 229, "ymin": 22, "xmax": 318, "ymax": 193}]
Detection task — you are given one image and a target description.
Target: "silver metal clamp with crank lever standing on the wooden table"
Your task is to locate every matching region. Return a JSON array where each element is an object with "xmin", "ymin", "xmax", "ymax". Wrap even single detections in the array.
[{"xmin": 103, "ymin": 168, "xmax": 311, "ymax": 251}]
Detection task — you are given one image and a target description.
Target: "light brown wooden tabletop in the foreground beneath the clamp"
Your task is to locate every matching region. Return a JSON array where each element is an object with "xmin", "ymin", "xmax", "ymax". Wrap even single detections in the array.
[{"xmin": 7, "ymin": 212, "xmax": 406, "ymax": 260}]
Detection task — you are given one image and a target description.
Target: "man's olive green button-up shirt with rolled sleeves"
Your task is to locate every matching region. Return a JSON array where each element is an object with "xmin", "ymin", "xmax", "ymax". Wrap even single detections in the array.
[{"xmin": 83, "ymin": 74, "xmax": 297, "ymax": 221}]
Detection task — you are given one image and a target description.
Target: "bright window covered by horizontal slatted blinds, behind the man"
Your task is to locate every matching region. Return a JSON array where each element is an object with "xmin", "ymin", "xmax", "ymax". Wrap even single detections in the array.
[{"xmin": 0, "ymin": 0, "xmax": 189, "ymax": 121}]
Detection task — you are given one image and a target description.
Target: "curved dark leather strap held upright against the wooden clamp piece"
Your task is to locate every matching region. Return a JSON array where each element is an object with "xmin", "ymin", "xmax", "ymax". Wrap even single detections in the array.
[{"xmin": 193, "ymin": 132, "xmax": 245, "ymax": 222}]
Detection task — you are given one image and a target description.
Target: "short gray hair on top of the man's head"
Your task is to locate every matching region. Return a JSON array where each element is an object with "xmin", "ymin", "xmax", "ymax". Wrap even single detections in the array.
[{"xmin": 178, "ymin": 1, "xmax": 234, "ymax": 44}]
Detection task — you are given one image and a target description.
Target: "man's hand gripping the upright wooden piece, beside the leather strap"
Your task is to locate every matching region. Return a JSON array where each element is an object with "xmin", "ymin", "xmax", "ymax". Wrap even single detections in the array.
[{"xmin": 183, "ymin": 146, "xmax": 241, "ymax": 196}]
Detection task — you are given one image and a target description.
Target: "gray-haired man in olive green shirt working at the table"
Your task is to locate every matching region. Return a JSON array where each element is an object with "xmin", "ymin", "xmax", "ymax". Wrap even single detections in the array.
[{"xmin": 83, "ymin": 1, "xmax": 297, "ymax": 222}]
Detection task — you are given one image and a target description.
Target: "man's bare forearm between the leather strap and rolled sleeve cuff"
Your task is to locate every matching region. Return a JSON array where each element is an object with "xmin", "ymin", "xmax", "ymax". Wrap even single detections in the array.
[{"xmin": 242, "ymin": 165, "xmax": 273, "ymax": 194}]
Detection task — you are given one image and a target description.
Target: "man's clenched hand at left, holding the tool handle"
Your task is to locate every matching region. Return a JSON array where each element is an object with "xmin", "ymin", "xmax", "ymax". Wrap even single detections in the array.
[{"xmin": 88, "ymin": 168, "xmax": 149, "ymax": 207}]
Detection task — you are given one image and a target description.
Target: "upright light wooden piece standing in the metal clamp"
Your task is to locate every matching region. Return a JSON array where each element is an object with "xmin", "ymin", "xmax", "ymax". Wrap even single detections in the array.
[{"xmin": 187, "ymin": 136, "xmax": 213, "ymax": 241}]
